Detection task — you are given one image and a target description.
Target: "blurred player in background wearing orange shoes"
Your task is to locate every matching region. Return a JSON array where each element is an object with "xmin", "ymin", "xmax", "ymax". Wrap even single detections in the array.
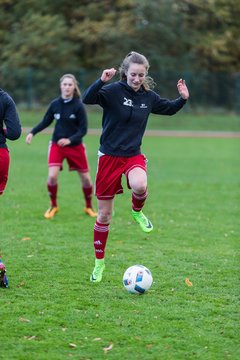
[{"xmin": 26, "ymin": 74, "xmax": 97, "ymax": 219}]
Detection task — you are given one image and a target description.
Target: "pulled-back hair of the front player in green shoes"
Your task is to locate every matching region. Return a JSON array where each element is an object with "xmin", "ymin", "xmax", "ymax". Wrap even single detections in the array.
[{"xmin": 119, "ymin": 51, "xmax": 155, "ymax": 90}]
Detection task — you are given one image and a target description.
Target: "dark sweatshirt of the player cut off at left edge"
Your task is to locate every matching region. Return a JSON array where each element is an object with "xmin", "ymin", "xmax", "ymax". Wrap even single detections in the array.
[{"xmin": 0, "ymin": 89, "xmax": 22, "ymax": 148}]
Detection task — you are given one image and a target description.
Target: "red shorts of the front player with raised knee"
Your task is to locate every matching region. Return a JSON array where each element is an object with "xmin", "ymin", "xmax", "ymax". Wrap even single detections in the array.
[{"xmin": 95, "ymin": 154, "xmax": 147, "ymax": 200}]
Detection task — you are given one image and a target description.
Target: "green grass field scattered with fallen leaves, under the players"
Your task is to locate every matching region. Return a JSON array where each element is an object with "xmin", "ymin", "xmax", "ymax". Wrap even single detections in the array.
[{"xmin": 0, "ymin": 123, "xmax": 240, "ymax": 360}]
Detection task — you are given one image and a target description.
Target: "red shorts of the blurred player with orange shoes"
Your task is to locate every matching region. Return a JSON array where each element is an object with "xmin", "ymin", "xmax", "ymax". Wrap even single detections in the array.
[{"xmin": 48, "ymin": 142, "xmax": 89, "ymax": 173}]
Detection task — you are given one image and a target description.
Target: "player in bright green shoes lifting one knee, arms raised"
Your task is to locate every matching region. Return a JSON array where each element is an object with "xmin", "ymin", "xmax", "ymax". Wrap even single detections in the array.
[{"xmin": 83, "ymin": 52, "xmax": 189, "ymax": 282}]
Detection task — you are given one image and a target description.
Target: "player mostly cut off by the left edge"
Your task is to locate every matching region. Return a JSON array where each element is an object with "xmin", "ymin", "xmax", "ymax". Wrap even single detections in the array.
[{"xmin": 0, "ymin": 89, "xmax": 21, "ymax": 287}]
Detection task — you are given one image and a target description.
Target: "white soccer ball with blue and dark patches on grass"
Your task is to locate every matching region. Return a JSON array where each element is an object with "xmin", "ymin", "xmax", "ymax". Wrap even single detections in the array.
[{"xmin": 123, "ymin": 265, "xmax": 153, "ymax": 294}]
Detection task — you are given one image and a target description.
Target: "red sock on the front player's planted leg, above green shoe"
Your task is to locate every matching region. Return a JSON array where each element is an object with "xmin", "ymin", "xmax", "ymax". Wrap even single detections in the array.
[{"xmin": 94, "ymin": 221, "xmax": 109, "ymax": 259}]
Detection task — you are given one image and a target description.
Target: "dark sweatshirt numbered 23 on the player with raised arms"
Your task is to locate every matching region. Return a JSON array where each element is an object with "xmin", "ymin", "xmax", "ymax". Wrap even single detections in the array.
[{"xmin": 83, "ymin": 79, "xmax": 186, "ymax": 156}]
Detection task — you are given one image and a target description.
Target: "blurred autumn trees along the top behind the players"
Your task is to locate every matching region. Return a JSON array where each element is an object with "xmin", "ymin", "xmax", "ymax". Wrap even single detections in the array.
[{"xmin": 0, "ymin": 0, "xmax": 240, "ymax": 73}]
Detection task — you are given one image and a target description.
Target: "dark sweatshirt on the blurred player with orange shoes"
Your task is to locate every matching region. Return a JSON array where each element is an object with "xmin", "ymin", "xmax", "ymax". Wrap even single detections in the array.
[{"xmin": 31, "ymin": 97, "xmax": 87, "ymax": 146}]
